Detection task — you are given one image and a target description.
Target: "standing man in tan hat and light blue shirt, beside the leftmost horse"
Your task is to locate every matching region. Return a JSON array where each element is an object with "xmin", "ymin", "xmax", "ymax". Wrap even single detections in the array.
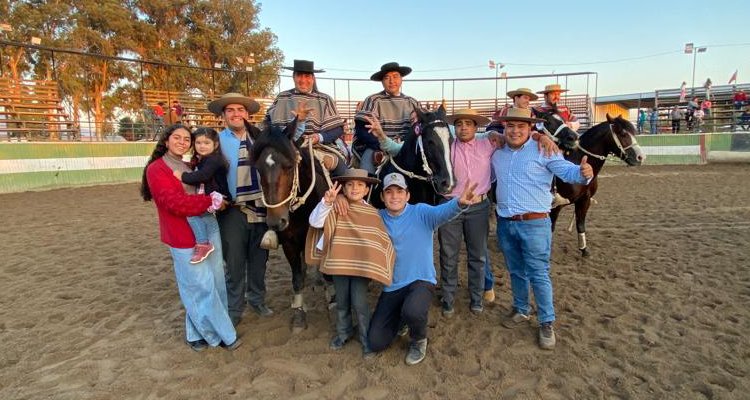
[{"xmin": 208, "ymin": 93, "xmax": 273, "ymax": 325}]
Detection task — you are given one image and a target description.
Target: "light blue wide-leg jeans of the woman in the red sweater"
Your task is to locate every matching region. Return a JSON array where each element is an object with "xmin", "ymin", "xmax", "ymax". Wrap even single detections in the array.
[{"xmin": 169, "ymin": 225, "xmax": 237, "ymax": 346}]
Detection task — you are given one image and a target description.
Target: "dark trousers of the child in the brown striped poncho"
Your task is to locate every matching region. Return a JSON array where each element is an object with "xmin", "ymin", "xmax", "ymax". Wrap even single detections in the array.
[{"xmin": 332, "ymin": 275, "xmax": 370, "ymax": 350}]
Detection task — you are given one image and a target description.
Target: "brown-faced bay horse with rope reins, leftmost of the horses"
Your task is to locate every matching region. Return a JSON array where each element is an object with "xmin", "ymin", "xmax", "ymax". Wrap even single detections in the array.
[{"xmin": 251, "ymin": 119, "xmax": 328, "ymax": 333}]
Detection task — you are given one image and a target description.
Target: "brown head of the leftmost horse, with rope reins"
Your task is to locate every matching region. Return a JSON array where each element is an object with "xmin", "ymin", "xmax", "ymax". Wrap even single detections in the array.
[{"xmin": 251, "ymin": 120, "xmax": 300, "ymax": 231}]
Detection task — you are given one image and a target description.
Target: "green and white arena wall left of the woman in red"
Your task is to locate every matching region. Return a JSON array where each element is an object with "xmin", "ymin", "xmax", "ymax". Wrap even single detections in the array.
[{"xmin": 0, "ymin": 142, "xmax": 154, "ymax": 193}]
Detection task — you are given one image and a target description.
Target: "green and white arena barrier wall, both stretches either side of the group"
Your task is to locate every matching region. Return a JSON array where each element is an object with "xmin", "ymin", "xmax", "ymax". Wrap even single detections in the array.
[{"xmin": 0, "ymin": 133, "xmax": 750, "ymax": 193}]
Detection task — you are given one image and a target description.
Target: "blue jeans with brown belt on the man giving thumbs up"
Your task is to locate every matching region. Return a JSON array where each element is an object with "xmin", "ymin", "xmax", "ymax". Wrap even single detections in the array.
[{"xmin": 497, "ymin": 217, "xmax": 555, "ymax": 324}]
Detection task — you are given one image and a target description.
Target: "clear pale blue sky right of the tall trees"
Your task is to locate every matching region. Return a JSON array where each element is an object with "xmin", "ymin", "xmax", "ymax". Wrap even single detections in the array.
[{"xmin": 259, "ymin": 0, "xmax": 750, "ymax": 100}]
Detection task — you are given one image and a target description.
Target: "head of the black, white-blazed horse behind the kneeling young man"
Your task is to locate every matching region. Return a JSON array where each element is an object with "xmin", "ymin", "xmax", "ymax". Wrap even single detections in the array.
[{"xmin": 412, "ymin": 105, "xmax": 455, "ymax": 195}]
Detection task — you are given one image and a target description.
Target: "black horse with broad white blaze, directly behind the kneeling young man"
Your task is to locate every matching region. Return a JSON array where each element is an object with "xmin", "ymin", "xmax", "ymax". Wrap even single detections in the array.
[{"xmin": 370, "ymin": 106, "xmax": 455, "ymax": 208}]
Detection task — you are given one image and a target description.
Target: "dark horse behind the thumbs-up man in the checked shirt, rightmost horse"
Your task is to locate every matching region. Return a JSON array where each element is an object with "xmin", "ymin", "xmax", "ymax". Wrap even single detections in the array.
[{"xmin": 550, "ymin": 114, "xmax": 645, "ymax": 257}]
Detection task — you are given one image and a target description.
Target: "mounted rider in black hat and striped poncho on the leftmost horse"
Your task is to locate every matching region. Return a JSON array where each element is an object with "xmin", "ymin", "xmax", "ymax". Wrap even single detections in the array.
[{"xmin": 266, "ymin": 60, "xmax": 346, "ymax": 175}]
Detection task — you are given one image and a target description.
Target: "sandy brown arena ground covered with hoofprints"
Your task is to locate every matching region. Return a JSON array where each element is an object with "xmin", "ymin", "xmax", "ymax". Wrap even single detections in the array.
[{"xmin": 0, "ymin": 164, "xmax": 750, "ymax": 400}]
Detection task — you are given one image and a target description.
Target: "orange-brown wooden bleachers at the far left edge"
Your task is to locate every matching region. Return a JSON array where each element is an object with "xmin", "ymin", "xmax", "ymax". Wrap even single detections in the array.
[{"xmin": 0, "ymin": 78, "xmax": 80, "ymax": 141}]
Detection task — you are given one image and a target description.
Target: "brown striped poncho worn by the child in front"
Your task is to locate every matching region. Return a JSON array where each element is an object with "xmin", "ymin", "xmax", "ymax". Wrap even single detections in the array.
[{"xmin": 305, "ymin": 203, "xmax": 396, "ymax": 286}]
